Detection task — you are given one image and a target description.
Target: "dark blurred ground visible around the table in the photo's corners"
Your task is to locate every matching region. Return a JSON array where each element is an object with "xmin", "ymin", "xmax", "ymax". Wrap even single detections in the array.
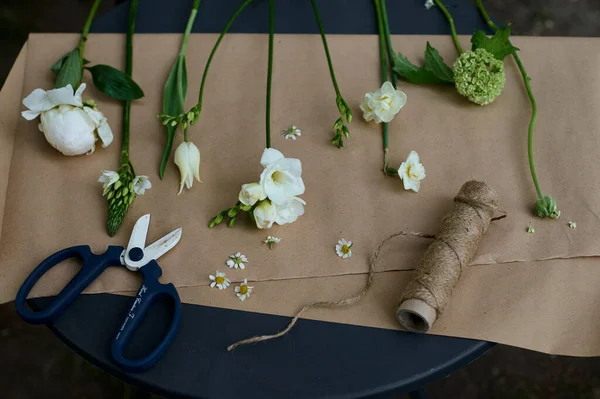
[{"xmin": 0, "ymin": 0, "xmax": 600, "ymax": 399}]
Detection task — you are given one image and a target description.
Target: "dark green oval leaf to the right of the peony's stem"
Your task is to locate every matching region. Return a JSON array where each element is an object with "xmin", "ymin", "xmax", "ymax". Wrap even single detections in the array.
[{"xmin": 86, "ymin": 65, "xmax": 144, "ymax": 101}]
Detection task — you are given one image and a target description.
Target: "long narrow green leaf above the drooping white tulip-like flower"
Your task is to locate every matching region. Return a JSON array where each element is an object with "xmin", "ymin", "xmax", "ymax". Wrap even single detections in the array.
[{"xmin": 158, "ymin": 55, "xmax": 187, "ymax": 179}]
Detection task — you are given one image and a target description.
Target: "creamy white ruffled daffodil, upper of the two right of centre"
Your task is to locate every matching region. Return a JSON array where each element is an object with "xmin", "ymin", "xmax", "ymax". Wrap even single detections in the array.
[{"xmin": 360, "ymin": 82, "xmax": 406, "ymax": 123}]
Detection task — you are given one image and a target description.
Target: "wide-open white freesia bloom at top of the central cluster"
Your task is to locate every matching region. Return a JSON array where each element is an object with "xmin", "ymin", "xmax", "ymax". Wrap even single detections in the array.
[{"xmin": 260, "ymin": 148, "xmax": 305, "ymax": 205}]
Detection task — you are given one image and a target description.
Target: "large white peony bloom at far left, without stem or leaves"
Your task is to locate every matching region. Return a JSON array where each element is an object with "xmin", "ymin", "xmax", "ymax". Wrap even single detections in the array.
[{"xmin": 21, "ymin": 83, "xmax": 113, "ymax": 156}]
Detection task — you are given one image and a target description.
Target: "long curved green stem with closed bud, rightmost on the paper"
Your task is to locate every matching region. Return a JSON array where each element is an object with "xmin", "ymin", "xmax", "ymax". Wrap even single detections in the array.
[{"xmin": 476, "ymin": 0, "xmax": 560, "ymax": 219}]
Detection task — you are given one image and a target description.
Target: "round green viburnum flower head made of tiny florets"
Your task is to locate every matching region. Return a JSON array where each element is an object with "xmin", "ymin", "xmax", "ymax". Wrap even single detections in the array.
[{"xmin": 454, "ymin": 48, "xmax": 505, "ymax": 105}]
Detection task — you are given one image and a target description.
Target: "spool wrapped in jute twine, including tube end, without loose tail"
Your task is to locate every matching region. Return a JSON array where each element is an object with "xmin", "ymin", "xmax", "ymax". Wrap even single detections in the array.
[{"xmin": 396, "ymin": 181, "xmax": 498, "ymax": 333}]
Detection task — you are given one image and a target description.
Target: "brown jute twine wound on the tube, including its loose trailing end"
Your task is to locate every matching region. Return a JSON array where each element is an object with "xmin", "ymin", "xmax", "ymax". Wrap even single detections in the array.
[{"xmin": 227, "ymin": 181, "xmax": 498, "ymax": 351}]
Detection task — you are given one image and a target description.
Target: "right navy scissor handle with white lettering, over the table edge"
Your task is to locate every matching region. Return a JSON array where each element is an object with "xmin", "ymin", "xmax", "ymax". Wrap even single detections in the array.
[{"xmin": 112, "ymin": 260, "xmax": 181, "ymax": 372}]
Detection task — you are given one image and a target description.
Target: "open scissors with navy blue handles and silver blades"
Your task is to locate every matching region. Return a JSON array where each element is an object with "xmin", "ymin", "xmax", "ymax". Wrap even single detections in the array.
[{"xmin": 15, "ymin": 215, "xmax": 181, "ymax": 372}]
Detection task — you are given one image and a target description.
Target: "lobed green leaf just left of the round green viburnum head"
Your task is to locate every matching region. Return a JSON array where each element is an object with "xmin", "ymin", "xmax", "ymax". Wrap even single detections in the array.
[{"xmin": 394, "ymin": 43, "xmax": 454, "ymax": 84}]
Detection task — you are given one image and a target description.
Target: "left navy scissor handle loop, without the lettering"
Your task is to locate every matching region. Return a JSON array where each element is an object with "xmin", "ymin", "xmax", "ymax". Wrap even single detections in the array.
[{"xmin": 15, "ymin": 245, "xmax": 124, "ymax": 324}]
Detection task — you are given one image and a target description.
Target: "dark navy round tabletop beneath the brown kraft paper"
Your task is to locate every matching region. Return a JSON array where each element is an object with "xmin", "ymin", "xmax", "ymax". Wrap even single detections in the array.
[{"xmin": 30, "ymin": 0, "xmax": 493, "ymax": 399}]
